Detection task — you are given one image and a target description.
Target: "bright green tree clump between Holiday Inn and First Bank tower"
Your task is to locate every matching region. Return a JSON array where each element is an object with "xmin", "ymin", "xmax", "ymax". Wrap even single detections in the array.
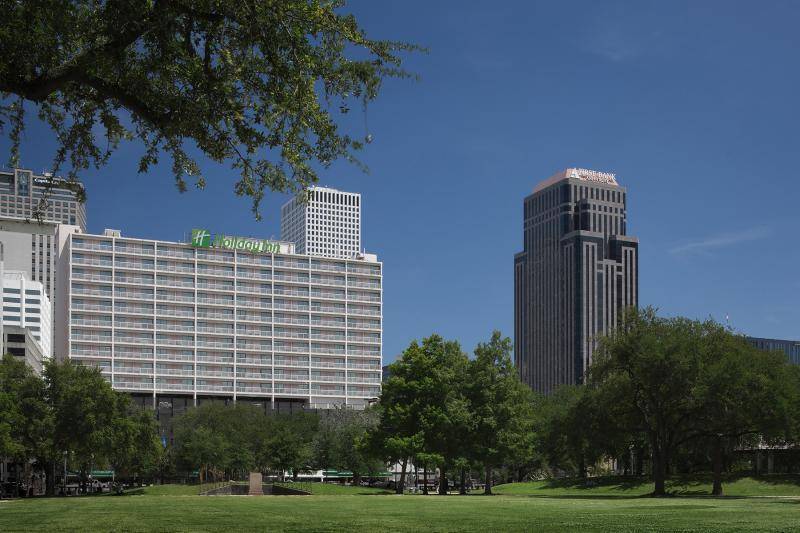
[{"xmin": 370, "ymin": 332, "xmax": 535, "ymax": 491}]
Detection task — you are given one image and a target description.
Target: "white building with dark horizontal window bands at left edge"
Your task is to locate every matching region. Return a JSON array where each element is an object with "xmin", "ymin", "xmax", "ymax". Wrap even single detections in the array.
[{"xmin": 2, "ymin": 270, "xmax": 53, "ymax": 358}]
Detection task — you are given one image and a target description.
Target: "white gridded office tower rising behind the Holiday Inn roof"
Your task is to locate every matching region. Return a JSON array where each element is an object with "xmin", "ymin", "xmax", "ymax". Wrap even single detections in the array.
[{"xmin": 281, "ymin": 187, "xmax": 361, "ymax": 259}]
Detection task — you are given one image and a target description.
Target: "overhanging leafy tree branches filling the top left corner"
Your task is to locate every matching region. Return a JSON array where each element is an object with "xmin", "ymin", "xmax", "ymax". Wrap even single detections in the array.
[{"xmin": 0, "ymin": 0, "xmax": 418, "ymax": 214}]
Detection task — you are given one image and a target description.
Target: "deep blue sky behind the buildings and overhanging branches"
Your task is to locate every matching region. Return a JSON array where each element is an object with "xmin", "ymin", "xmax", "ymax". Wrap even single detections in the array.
[{"xmin": 0, "ymin": 0, "xmax": 800, "ymax": 362}]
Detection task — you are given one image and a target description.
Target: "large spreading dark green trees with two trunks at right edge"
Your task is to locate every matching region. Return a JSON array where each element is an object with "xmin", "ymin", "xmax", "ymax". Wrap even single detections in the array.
[{"xmin": 588, "ymin": 308, "xmax": 798, "ymax": 495}]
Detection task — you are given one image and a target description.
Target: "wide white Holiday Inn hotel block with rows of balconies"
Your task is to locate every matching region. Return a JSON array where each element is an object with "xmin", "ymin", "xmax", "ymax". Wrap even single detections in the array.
[{"xmin": 60, "ymin": 230, "xmax": 382, "ymax": 410}]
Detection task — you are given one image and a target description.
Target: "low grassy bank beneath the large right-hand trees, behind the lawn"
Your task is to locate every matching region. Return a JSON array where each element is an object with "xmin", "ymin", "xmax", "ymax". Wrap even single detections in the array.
[{"xmin": 494, "ymin": 475, "xmax": 800, "ymax": 498}]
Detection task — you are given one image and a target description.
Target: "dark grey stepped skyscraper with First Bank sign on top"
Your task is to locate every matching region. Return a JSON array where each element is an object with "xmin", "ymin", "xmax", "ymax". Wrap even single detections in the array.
[{"xmin": 514, "ymin": 168, "xmax": 639, "ymax": 393}]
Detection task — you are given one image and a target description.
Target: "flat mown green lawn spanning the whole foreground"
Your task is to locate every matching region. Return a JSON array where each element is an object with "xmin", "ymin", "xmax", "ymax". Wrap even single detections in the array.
[{"xmin": 0, "ymin": 480, "xmax": 800, "ymax": 532}]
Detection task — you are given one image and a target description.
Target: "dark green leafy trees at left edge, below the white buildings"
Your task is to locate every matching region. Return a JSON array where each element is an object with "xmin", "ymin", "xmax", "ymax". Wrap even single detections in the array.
[{"xmin": 0, "ymin": 355, "xmax": 158, "ymax": 492}]
